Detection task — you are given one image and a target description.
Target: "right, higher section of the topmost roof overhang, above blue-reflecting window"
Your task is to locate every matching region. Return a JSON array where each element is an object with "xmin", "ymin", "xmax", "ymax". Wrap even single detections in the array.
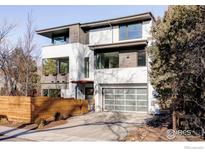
[{"xmin": 81, "ymin": 12, "xmax": 155, "ymax": 29}]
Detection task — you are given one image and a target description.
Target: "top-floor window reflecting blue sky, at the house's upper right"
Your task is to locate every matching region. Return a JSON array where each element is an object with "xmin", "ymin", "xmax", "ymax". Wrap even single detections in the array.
[{"xmin": 119, "ymin": 23, "xmax": 142, "ymax": 40}]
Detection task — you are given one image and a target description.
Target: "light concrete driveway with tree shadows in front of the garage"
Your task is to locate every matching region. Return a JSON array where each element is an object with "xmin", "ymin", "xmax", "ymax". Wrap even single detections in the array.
[{"xmin": 0, "ymin": 112, "xmax": 150, "ymax": 141}]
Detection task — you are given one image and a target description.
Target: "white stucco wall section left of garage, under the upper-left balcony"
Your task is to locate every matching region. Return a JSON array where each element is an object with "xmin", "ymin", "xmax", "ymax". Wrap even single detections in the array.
[{"xmin": 42, "ymin": 43, "xmax": 94, "ymax": 99}]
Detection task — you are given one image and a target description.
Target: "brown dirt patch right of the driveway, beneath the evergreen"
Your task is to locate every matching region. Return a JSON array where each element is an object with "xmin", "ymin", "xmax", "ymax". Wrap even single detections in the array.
[{"xmin": 122, "ymin": 115, "xmax": 203, "ymax": 141}]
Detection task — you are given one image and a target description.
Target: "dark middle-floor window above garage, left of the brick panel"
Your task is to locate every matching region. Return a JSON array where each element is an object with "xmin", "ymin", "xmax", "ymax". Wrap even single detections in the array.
[{"xmin": 96, "ymin": 52, "xmax": 119, "ymax": 69}]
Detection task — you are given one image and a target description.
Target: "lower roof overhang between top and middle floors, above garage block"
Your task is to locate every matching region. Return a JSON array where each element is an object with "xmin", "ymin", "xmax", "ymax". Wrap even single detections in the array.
[{"xmin": 89, "ymin": 40, "xmax": 148, "ymax": 50}]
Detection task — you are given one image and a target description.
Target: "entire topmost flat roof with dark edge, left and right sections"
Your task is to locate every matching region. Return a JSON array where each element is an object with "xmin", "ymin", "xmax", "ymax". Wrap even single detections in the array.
[{"xmin": 36, "ymin": 12, "xmax": 155, "ymax": 37}]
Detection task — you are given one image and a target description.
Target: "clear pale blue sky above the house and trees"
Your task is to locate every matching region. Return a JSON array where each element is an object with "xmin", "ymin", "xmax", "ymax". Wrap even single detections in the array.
[{"xmin": 0, "ymin": 5, "xmax": 167, "ymax": 54}]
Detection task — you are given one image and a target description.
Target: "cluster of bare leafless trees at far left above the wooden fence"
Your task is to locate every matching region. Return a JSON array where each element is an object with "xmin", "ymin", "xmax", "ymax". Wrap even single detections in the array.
[{"xmin": 0, "ymin": 13, "xmax": 40, "ymax": 96}]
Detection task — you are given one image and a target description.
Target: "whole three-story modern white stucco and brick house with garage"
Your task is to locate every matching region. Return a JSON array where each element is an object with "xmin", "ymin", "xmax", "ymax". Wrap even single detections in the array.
[{"xmin": 37, "ymin": 12, "xmax": 155, "ymax": 112}]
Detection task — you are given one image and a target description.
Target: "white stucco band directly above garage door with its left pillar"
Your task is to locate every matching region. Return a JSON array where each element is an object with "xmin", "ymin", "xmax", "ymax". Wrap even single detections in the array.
[{"xmin": 94, "ymin": 67, "xmax": 148, "ymax": 111}]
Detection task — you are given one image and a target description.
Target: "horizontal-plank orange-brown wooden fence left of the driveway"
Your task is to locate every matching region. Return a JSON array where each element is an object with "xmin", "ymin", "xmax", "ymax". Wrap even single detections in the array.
[{"xmin": 0, "ymin": 96, "xmax": 88, "ymax": 123}]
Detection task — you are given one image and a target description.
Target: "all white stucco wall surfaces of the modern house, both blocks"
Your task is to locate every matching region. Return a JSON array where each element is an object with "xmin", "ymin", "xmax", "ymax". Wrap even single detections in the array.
[{"xmin": 38, "ymin": 12, "xmax": 155, "ymax": 113}]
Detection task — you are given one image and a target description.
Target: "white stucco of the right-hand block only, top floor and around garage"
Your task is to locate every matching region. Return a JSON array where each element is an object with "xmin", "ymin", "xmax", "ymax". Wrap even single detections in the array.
[{"xmin": 89, "ymin": 20, "xmax": 155, "ymax": 113}]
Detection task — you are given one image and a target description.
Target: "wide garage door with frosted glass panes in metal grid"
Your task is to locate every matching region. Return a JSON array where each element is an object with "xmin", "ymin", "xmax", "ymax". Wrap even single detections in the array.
[{"xmin": 103, "ymin": 88, "xmax": 148, "ymax": 112}]
